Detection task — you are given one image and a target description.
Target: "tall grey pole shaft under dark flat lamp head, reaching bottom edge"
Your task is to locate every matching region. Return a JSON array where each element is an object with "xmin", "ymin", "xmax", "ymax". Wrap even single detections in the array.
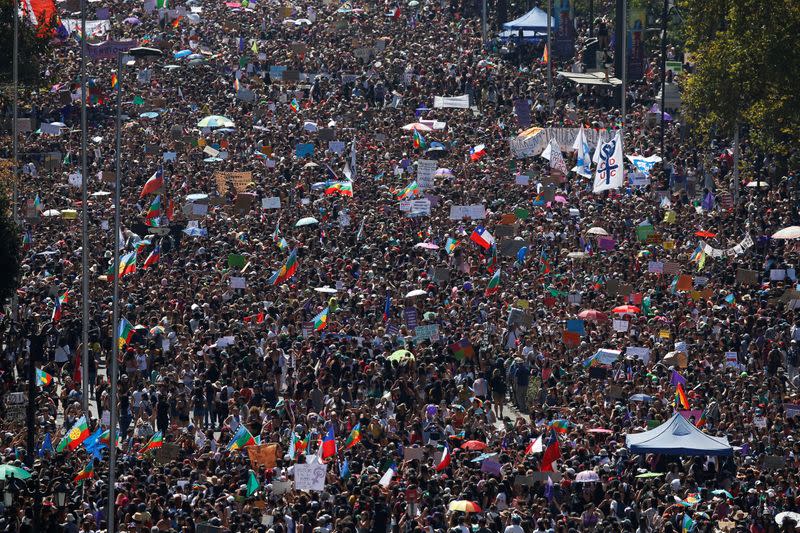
[{"xmin": 108, "ymin": 51, "xmax": 124, "ymax": 533}]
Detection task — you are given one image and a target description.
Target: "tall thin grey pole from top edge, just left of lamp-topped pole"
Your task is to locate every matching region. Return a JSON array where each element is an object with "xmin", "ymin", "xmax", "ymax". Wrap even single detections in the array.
[{"xmin": 81, "ymin": 0, "xmax": 91, "ymax": 415}]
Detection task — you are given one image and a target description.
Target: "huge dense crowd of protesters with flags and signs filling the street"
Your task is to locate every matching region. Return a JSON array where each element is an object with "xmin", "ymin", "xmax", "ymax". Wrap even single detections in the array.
[{"xmin": 0, "ymin": 0, "xmax": 800, "ymax": 533}]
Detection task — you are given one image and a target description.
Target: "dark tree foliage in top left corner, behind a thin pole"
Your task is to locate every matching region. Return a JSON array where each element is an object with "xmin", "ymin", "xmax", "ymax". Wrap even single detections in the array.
[{"xmin": 0, "ymin": 0, "xmax": 50, "ymax": 85}]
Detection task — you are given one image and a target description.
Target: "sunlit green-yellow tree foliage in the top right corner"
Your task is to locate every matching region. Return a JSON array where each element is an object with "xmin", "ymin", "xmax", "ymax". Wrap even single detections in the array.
[{"xmin": 679, "ymin": 0, "xmax": 800, "ymax": 153}]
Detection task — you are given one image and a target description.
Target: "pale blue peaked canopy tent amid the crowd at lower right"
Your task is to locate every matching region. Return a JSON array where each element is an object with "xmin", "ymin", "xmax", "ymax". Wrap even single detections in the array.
[{"xmin": 625, "ymin": 413, "xmax": 733, "ymax": 456}]
